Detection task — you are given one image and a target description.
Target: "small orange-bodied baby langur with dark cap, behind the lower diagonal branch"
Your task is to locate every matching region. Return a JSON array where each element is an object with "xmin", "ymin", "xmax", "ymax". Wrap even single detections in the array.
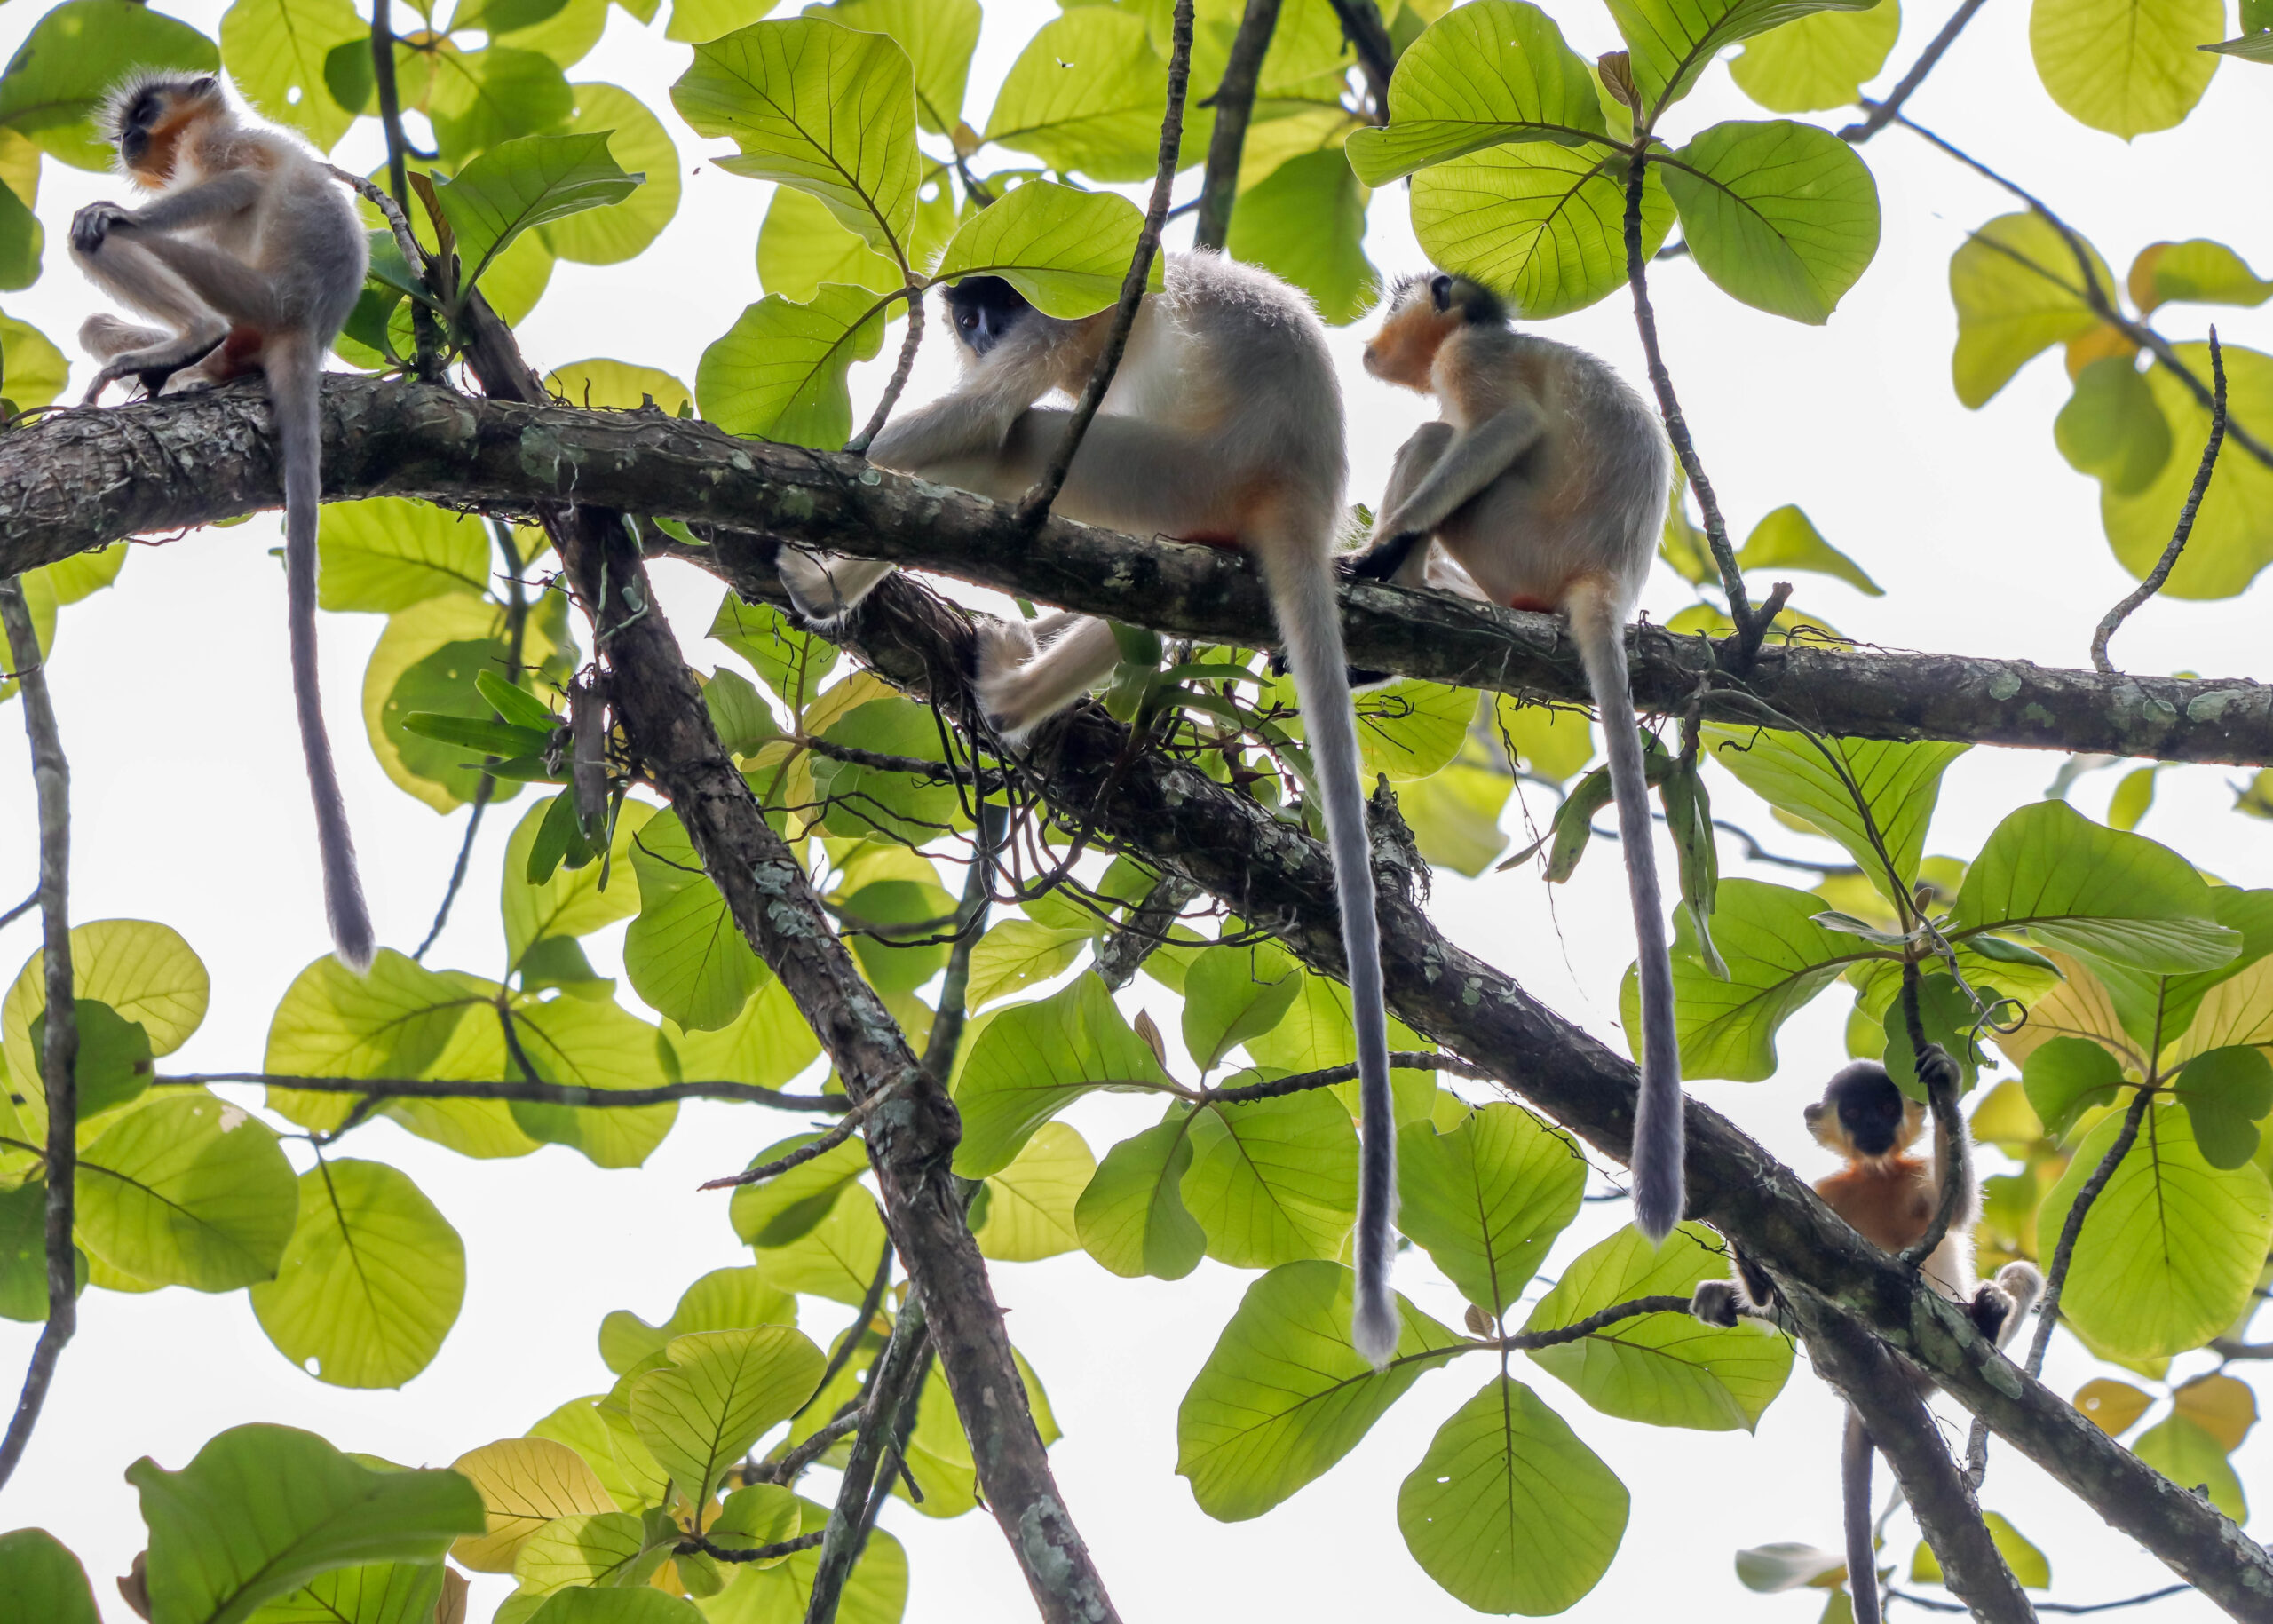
[{"xmin": 1689, "ymin": 1046, "xmax": 2043, "ymax": 1624}]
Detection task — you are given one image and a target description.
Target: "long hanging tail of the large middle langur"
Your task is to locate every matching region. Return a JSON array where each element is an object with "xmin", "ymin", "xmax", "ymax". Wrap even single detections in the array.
[{"xmin": 1253, "ymin": 536, "xmax": 1400, "ymax": 1367}]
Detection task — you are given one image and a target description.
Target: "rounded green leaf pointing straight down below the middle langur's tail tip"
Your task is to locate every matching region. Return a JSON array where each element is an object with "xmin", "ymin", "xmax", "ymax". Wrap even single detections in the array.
[{"xmin": 1398, "ymin": 1376, "xmax": 1628, "ymax": 1612}]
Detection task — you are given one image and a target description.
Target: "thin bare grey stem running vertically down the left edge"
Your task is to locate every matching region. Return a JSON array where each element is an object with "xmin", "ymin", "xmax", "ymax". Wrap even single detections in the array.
[{"xmin": 0, "ymin": 575, "xmax": 80, "ymax": 1485}]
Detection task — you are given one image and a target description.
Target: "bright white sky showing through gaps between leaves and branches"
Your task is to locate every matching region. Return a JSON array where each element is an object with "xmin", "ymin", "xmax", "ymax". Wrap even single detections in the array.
[{"xmin": 0, "ymin": 0, "xmax": 2273, "ymax": 1624}]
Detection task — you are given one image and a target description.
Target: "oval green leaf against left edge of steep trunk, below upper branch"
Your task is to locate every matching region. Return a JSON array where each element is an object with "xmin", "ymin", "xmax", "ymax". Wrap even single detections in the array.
[{"xmin": 609, "ymin": 812, "xmax": 768, "ymax": 1030}]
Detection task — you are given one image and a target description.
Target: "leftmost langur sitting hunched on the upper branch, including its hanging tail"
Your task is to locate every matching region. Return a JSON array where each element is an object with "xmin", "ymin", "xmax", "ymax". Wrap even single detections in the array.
[{"xmin": 70, "ymin": 75, "xmax": 373, "ymax": 971}]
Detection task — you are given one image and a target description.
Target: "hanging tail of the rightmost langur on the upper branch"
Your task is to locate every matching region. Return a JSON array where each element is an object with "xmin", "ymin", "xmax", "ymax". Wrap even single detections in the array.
[{"xmin": 1568, "ymin": 580, "xmax": 1689, "ymax": 1242}]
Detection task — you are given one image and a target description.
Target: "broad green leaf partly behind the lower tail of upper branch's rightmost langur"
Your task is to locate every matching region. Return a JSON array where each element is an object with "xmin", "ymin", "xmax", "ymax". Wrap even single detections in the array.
[{"xmin": 1619, "ymin": 880, "xmax": 1862, "ymax": 1082}]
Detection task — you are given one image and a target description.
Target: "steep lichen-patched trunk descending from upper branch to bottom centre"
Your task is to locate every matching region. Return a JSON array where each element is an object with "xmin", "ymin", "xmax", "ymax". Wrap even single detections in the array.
[{"xmin": 445, "ymin": 309, "xmax": 1116, "ymax": 1624}]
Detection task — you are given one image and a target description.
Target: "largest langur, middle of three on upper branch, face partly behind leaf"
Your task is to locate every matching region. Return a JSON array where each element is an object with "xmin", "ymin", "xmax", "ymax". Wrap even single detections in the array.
[{"xmin": 780, "ymin": 250, "xmax": 1400, "ymax": 1365}]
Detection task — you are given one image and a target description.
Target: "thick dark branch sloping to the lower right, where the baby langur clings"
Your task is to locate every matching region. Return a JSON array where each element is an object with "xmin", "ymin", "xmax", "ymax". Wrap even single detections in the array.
[{"xmin": 686, "ymin": 557, "xmax": 2273, "ymax": 1617}]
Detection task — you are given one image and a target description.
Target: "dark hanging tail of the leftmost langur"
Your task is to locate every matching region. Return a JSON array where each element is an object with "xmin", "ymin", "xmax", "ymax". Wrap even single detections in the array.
[{"xmin": 261, "ymin": 337, "xmax": 377, "ymax": 973}]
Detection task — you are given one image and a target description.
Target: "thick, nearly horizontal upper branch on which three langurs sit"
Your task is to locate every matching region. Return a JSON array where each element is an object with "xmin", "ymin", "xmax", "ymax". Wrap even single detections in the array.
[{"xmin": 0, "ymin": 377, "xmax": 2273, "ymax": 766}]
